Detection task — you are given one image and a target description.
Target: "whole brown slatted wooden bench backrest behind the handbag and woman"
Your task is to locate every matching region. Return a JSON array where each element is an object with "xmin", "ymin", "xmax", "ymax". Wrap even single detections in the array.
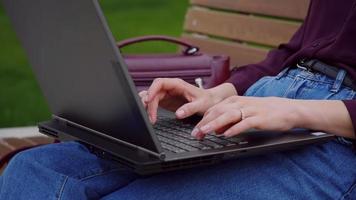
[{"xmin": 182, "ymin": 0, "xmax": 309, "ymax": 67}]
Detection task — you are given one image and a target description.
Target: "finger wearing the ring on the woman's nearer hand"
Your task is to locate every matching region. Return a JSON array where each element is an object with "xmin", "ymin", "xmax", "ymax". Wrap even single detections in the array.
[{"xmin": 200, "ymin": 109, "xmax": 241, "ymax": 134}]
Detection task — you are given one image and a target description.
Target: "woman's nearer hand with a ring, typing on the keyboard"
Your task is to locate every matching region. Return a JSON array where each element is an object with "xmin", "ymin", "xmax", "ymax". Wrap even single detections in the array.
[{"xmin": 192, "ymin": 96, "xmax": 297, "ymax": 139}]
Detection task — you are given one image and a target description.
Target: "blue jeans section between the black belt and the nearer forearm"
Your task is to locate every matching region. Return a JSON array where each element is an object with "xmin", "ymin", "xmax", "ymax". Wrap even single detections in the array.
[{"xmin": 245, "ymin": 68, "xmax": 356, "ymax": 100}]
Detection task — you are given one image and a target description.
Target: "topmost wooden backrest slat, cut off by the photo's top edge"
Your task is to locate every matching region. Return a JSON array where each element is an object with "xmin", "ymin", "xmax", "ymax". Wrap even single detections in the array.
[{"xmin": 191, "ymin": 0, "xmax": 310, "ymax": 20}]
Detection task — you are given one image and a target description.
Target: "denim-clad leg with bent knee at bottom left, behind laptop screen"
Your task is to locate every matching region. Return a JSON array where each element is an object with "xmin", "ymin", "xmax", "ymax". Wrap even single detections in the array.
[{"xmin": 0, "ymin": 142, "xmax": 136, "ymax": 199}]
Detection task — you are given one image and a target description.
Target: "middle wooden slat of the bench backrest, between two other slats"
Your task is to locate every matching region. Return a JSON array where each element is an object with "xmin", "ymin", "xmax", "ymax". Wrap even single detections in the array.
[{"xmin": 184, "ymin": 8, "xmax": 300, "ymax": 47}]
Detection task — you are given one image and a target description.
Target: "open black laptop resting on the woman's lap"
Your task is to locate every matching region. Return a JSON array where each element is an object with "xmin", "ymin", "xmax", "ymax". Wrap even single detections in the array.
[{"xmin": 3, "ymin": 0, "xmax": 334, "ymax": 174}]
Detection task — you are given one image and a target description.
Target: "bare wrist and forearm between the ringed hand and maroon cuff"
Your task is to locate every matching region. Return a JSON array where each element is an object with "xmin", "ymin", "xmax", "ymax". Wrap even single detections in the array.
[{"xmin": 293, "ymin": 100, "xmax": 355, "ymax": 138}]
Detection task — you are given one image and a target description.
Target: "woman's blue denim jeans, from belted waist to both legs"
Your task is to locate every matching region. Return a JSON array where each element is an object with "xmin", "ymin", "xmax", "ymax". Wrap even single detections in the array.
[{"xmin": 0, "ymin": 69, "xmax": 356, "ymax": 200}]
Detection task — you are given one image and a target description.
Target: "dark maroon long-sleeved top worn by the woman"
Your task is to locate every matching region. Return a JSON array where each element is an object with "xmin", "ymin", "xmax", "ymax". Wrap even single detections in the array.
[{"xmin": 227, "ymin": 0, "xmax": 356, "ymax": 134}]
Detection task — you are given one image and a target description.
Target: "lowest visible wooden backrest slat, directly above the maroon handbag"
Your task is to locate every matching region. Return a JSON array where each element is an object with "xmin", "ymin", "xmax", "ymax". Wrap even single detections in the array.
[{"xmin": 182, "ymin": 34, "xmax": 268, "ymax": 67}]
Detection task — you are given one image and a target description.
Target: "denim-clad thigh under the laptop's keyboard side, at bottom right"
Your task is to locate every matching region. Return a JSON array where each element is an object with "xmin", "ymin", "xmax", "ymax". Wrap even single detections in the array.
[{"xmin": 103, "ymin": 141, "xmax": 356, "ymax": 200}]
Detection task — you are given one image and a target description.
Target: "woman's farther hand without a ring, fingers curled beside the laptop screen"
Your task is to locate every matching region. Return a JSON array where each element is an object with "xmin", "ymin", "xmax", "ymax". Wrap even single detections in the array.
[{"xmin": 139, "ymin": 78, "xmax": 237, "ymax": 124}]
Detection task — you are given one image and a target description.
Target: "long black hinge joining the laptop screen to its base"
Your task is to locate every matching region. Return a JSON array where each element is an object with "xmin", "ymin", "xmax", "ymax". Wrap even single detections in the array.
[{"xmin": 52, "ymin": 115, "xmax": 166, "ymax": 160}]
